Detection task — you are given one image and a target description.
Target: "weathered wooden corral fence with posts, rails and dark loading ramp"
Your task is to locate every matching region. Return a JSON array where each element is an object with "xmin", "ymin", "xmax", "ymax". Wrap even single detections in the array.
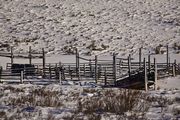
[{"xmin": 0, "ymin": 47, "xmax": 180, "ymax": 90}]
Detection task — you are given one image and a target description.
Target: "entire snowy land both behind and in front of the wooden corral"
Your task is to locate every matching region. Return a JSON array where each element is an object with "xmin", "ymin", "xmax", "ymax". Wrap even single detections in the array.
[{"xmin": 0, "ymin": 0, "xmax": 180, "ymax": 120}]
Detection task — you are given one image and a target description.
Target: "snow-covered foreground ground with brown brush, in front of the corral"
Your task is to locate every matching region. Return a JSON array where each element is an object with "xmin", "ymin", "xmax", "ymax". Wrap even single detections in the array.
[{"xmin": 0, "ymin": 76, "xmax": 180, "ymax": 120}]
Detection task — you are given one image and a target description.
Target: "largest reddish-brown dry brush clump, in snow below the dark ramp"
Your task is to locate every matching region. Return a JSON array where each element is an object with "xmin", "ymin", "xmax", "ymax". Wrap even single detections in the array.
[{"xmin": 77, "ymin": 89, "xmax": 147, "ymax": 117}]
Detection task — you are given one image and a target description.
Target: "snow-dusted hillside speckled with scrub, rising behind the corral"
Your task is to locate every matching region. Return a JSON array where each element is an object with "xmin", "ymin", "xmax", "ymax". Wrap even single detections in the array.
[{"xmin": 0, "ymin": 0, "xmax": 180, "ymax": 55}]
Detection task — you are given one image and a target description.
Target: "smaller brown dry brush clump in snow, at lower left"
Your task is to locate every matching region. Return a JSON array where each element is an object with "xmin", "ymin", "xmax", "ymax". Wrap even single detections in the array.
[{"xmin": 6, "ymin": 88, "xmax": 63, "ymax": 107}]
